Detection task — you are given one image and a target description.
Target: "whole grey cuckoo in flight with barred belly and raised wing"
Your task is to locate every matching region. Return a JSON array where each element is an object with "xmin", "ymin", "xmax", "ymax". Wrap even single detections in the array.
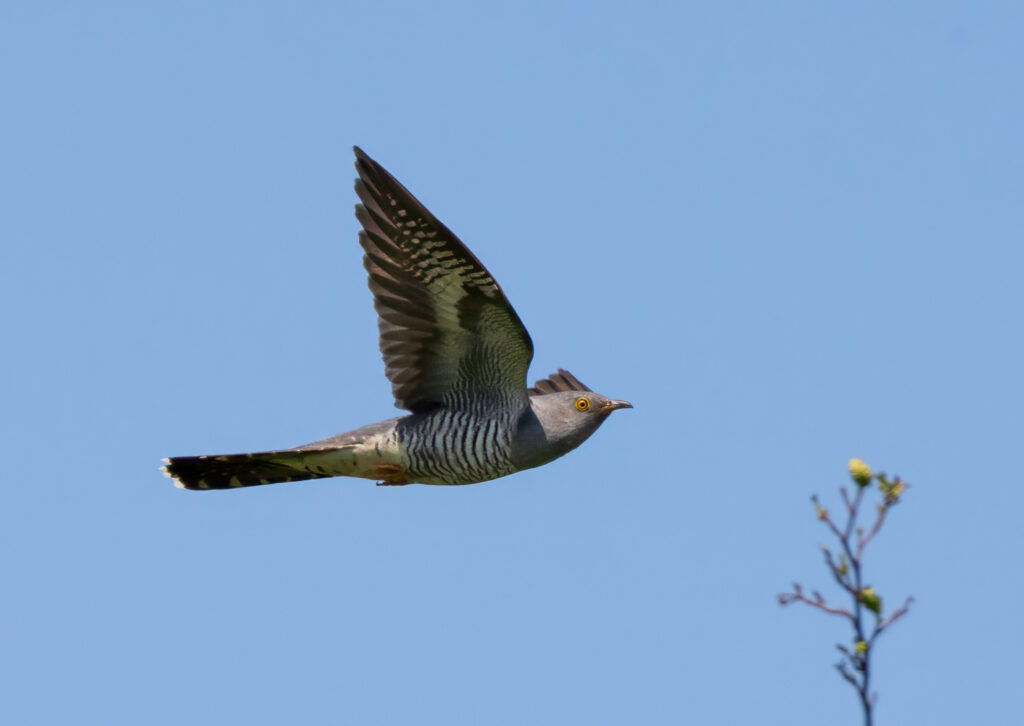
[{"xmin": 163, "ymin": 146, "xmax": 633, "ymax": 489}]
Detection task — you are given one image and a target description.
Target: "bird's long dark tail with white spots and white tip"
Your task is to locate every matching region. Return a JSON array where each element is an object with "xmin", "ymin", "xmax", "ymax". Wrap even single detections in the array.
[{"xmin": 163, "ymin": 447, "xmax": 351, "ymax": 489}]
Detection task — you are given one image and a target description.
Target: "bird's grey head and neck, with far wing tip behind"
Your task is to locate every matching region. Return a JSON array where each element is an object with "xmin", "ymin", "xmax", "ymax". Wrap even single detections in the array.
[{"xmin": 513, "ymin": 369, "xmax": 633, "ymax": 469}]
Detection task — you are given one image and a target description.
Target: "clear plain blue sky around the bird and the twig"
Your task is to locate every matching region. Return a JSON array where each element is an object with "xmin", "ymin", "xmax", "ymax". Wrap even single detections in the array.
[{"xmin": 0, "ymin": 2, "xmax": 1024, "ymax": 725}]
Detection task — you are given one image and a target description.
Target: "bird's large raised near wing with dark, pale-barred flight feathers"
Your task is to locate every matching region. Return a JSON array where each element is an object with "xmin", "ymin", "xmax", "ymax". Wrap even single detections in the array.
[{"xmin": 355, "ymin": 146, "xmax": 534, "ymax": 413}]
